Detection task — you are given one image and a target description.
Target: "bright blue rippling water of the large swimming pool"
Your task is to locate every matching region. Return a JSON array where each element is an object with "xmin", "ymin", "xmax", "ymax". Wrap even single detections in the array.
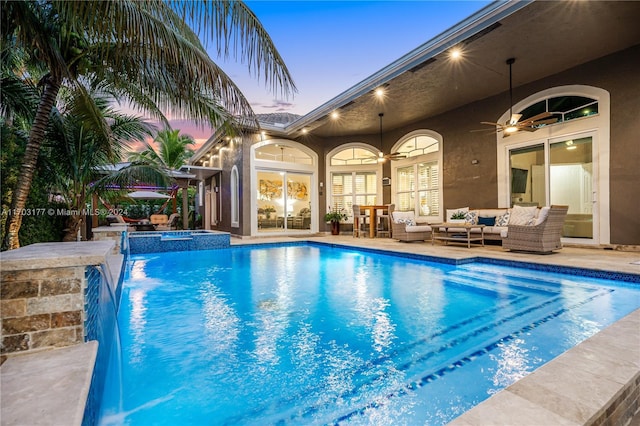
[{"xmin": 100, "ymin": 244, "xmax": 640, "ymax": 425}]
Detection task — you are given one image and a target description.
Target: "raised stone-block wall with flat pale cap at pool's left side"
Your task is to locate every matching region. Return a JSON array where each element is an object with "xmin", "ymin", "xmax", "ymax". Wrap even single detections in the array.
[{"xmin": 0, "ymin": 241, "xmax": 114, "ymax": 362}]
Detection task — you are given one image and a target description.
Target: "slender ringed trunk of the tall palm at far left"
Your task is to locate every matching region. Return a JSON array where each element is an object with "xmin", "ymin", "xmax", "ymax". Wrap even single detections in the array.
[{"xmin": 7, "ymin": 76, "xmax": 60, "ymax": 250}]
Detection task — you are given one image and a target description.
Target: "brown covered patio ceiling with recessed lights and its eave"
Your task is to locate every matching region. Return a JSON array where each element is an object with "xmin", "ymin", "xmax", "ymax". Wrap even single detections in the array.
[{"xmin": 283, "ymin": 0, "xmax": 640, "ymax": 137}]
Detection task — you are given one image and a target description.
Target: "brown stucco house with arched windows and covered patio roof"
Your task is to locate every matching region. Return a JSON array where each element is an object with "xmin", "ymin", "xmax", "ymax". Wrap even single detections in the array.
[{"xmin": 186, "ymin": 1, "xmax": 640, "ymax": 248}]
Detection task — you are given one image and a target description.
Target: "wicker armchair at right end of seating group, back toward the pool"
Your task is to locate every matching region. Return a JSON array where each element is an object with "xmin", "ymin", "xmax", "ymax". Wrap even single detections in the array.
[{"xmin": 502, "ymin": 206, "xmax": 569, "ymax": 253}]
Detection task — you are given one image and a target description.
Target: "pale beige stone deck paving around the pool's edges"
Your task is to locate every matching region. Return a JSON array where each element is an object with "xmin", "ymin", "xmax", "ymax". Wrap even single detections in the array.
[{"xmin": 0, "ymin": 235, "xmax": 640, "ymax": 426}]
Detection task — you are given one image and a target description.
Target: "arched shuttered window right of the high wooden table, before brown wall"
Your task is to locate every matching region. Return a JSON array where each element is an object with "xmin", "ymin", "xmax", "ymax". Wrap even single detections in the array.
[{"xmin": 391, "ymin": 130, "xmax": 442, "ymax": 220}]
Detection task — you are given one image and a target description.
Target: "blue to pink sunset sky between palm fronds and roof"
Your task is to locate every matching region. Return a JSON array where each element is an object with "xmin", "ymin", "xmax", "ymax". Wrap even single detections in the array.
[{"xmin": 160, "ymin": 0, "xmax": 490, "ymax": 150}]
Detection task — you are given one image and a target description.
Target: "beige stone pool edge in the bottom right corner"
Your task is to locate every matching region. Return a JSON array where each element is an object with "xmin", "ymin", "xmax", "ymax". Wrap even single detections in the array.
[{"xmin": 449, "ymin": 309, "xmax": 640, "ymax": 426}]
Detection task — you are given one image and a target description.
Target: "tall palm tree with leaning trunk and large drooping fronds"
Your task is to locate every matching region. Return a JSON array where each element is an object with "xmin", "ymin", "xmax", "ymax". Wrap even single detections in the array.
[{"xmin": 0, "ymin": 0, "xmax": 295, "ymax": 249}]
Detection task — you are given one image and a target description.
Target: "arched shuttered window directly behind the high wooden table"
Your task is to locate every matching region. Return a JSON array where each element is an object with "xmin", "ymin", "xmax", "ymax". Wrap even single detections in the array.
[{"xmin": 327, "ymin": 142, "xmax": 382, "ymax": 216}]
